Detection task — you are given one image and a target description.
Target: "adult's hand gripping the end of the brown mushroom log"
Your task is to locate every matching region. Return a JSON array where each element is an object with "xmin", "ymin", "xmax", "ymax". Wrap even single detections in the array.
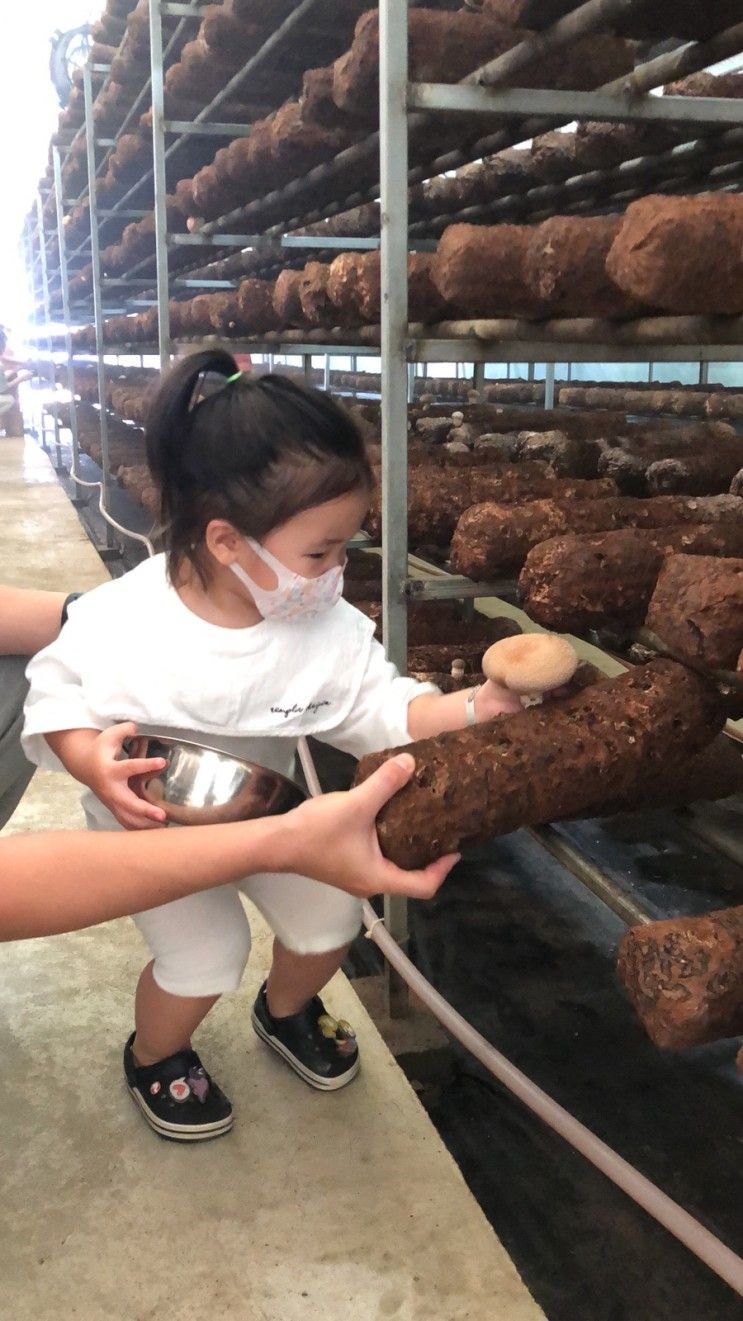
[{"xmin": 282, "ymin": 753, "xmax": 460, "ymax": 900}]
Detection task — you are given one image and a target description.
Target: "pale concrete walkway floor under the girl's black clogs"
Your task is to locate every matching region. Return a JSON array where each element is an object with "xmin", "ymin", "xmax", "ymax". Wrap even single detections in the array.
[{"xmin": 0, "ymin": 440, "xmax": 542, "ymax": 1321}]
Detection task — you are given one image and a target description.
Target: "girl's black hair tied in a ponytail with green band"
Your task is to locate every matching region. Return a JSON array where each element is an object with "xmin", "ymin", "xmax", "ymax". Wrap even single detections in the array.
[{"xmin": 145, "ymin": 349, "xmax": 374, "ymax": 584}]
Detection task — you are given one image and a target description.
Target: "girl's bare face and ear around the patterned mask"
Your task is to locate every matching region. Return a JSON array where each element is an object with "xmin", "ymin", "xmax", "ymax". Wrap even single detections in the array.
[{"xmin": 238, "ymin": 490, "xmax": 369, "ymax": 589}]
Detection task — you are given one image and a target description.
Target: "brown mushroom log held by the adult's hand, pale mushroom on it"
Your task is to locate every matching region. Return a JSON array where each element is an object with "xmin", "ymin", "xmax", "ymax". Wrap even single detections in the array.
[{"xmin": 356, "ymin": 661, "xmax": 724, "ymax": 868}]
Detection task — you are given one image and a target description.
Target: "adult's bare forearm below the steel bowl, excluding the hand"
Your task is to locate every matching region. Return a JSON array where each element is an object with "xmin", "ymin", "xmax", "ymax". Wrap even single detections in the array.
[{"xmin": 0, "ymin": 818, "xmax": 286, "ymax": 941}]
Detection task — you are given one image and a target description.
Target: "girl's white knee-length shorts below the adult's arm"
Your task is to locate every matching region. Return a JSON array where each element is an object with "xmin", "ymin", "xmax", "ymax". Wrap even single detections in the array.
[{"xmin": 87, "ymin": 815, "xmax": 361, "ymax": 996}]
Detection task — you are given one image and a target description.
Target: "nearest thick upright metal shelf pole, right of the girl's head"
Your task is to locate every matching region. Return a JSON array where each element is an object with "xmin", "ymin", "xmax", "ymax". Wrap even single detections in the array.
[{"xmin": 379, "ymin": 0, "xmax": 409, "ymax": 1017}]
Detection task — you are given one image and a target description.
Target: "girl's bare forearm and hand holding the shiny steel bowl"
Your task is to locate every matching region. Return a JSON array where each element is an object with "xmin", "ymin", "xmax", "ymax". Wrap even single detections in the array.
[{"xmin": 44, "ymin": 723, "xmax": 165, "ymax": 830}]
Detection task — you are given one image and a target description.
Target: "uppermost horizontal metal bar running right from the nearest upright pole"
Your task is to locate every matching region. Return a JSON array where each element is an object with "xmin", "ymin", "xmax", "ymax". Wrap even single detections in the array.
[{"xmin": 407, "ymin": 83, "xmax": 743, "ymax": 124}]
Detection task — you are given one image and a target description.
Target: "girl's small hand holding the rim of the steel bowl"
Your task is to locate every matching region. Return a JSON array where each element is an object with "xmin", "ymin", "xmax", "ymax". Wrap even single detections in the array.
[{"xmin": 85, "ymin": 721, "xmax": 165, "ymax": 830}]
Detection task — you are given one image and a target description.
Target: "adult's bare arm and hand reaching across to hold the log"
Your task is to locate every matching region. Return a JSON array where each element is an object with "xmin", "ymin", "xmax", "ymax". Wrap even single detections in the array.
[{"xmin": 0, "ymin": 753, "xmax": 457, "ymax": 941}]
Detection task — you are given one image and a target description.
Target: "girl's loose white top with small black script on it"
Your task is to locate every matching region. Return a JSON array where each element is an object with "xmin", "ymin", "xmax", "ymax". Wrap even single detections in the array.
[{"xmin": 22, "ymin": 555, "xmax": 436, "ymax": 826}]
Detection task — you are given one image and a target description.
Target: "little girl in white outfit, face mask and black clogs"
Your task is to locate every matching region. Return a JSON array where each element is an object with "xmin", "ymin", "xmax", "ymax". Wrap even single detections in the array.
[{"xmin": 24, "ymin": 350, "xmax": 516, "ymax": 1141}]
